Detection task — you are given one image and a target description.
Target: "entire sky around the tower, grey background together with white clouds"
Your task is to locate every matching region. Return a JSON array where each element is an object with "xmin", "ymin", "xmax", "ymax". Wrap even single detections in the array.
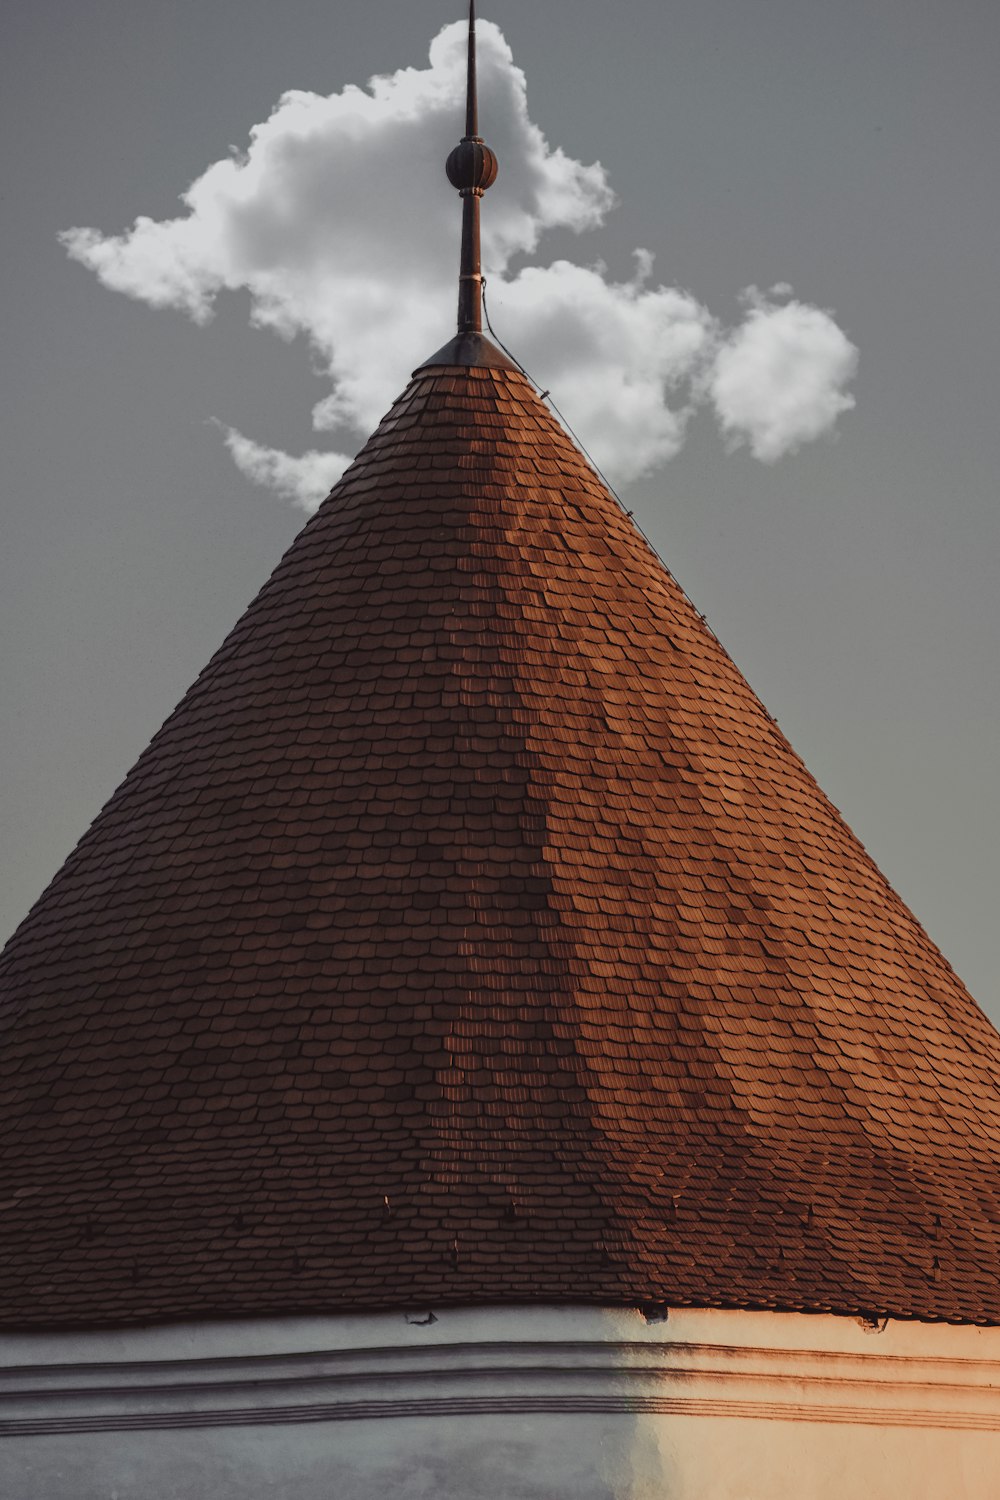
[{"xmin": 0, "ymin": 0, "xmax": 1000, "ymax": 1022}]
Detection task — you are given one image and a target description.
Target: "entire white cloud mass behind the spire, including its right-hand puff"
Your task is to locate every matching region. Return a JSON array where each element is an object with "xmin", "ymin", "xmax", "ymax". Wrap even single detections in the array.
[{"xmin": 61, "ymin": 21, "xmax": 855, "ymax": 509}]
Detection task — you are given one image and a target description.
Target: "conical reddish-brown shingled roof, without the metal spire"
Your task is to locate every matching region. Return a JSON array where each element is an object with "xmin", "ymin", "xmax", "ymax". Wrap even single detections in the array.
[{"xmin": 0, "ymin": 365, "xmax": 1000, "ymax": 1326}]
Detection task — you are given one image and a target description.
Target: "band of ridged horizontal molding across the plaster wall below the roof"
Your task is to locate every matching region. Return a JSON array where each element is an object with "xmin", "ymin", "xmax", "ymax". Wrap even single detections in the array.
[{"xmin": 7, "ymin": 1340, "xmax": 1000, "ymax": 1437}]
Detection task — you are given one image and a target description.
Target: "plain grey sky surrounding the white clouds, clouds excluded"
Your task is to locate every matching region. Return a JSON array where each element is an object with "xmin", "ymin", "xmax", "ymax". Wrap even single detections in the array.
[{"xmin": 0, "ymin": 0, "xmax": 1000, "ymax": 1020}]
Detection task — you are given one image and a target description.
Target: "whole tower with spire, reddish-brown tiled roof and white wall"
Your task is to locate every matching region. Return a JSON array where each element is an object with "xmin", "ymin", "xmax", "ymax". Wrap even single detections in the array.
[{"xmin": 0, "ymin": 5, "xmax": 1000, "ymax": 1500}]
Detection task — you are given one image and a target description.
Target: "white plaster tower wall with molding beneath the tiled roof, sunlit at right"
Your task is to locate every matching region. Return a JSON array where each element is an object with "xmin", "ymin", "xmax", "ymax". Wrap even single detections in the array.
[{"xmin": 0, "ymin": 1307, "xmax": 1000, "ymax": 1500}]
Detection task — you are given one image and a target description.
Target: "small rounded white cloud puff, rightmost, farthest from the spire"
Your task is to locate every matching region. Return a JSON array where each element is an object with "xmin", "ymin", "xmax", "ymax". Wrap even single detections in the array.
[{"xmin": 708, "ymin": 284, "xmax": 858, "ymax": 464}]
